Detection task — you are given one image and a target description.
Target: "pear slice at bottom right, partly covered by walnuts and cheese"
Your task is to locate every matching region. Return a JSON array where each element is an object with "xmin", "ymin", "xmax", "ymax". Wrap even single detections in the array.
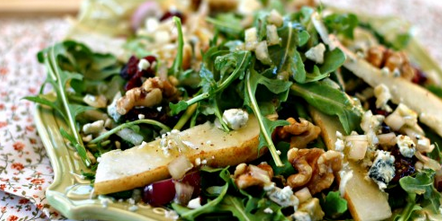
[{"xmin": 310, "ymin": 107, "xmax": 392, "ymax": 221}]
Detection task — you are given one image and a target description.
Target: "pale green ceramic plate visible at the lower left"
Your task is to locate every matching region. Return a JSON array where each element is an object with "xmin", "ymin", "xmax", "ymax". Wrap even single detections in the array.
[{"xmin": 35, "ymin": 105, "xmax": 174, "ymax": 221}]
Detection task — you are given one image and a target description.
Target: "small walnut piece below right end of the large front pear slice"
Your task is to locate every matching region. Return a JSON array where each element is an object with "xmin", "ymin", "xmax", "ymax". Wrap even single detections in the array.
[{"xmin": 233, "ymin": 163, "xmax": 273, "ymax": 189}]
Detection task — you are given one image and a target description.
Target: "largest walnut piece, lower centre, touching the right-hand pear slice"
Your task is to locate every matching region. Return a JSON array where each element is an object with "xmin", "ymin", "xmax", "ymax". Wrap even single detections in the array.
[{"xmin": 287, "ymin": 148, "xmax": 342, "ymax": 195}]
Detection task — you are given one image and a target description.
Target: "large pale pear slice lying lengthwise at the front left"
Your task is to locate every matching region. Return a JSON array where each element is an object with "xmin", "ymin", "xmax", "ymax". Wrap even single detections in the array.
[{"xmin": 94, "ymin": 116, "xmax": 258, "ymax": 194}]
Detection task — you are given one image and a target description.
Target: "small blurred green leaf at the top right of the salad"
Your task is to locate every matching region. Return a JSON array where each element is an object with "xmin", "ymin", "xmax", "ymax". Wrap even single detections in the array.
[{"xmin": 324, "ymin": 13, "xmax": 359, "ymax": 39}]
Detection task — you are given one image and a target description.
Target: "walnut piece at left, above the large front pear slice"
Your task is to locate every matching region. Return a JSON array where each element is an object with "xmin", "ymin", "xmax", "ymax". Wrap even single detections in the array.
[{"xmin": 117, "ymin": 77, "xmax": 177, "ymax": 115}]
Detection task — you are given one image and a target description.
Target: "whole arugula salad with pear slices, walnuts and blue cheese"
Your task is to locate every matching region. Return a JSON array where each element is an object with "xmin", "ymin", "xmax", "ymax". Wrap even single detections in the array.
[{"xmin": 26, "ymin": 0, "xmax": 442, "ymax": 220}]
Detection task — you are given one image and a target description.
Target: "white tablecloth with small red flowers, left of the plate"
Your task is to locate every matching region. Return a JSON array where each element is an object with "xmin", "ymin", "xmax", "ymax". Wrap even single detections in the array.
[{"xmin": 0, "ymin": 17, "xmax": 68, "ymax": 221}]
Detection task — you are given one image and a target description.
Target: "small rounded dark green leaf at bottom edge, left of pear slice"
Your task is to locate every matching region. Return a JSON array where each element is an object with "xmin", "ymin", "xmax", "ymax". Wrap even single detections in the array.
[{"xmin": 321, "ymin": 191, "xmax": 348, "ymax": 218}]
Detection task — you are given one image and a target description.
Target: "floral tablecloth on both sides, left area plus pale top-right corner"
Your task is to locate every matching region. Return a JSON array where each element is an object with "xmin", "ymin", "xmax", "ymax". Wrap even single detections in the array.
[{"xmin": 0, "ymin": 0, "xmax": 442, "ymax": 221}]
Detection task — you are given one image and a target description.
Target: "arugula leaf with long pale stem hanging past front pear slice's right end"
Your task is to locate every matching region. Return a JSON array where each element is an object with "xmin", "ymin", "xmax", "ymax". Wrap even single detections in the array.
[{"xmin": 244, "ymin": 68, "xmax": 292, "ymax": 167}]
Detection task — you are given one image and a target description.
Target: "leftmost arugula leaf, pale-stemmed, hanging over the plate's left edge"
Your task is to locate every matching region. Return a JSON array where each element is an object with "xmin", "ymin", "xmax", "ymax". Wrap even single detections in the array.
[{"xmin": 25, "ymin": 40, "xmax": 121, "ymax": 167}]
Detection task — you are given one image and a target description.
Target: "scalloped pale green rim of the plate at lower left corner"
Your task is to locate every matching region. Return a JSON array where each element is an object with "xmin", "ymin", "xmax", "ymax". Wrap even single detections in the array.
[{"xmin": 34, "ymin": 104, "xmax": 172, "ymax": 221}]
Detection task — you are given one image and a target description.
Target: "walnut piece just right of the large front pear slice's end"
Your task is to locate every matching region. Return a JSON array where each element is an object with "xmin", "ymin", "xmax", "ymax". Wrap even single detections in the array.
[{"xmin": 276, "ymin": 117, "xmax": 321, "ymax": 149}]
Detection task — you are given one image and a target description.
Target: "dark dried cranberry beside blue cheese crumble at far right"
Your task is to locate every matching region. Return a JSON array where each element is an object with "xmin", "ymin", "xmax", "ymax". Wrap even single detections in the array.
[{"xmin": 391, "ymin": 146, "xmax": 417, "ymax": 182}]
